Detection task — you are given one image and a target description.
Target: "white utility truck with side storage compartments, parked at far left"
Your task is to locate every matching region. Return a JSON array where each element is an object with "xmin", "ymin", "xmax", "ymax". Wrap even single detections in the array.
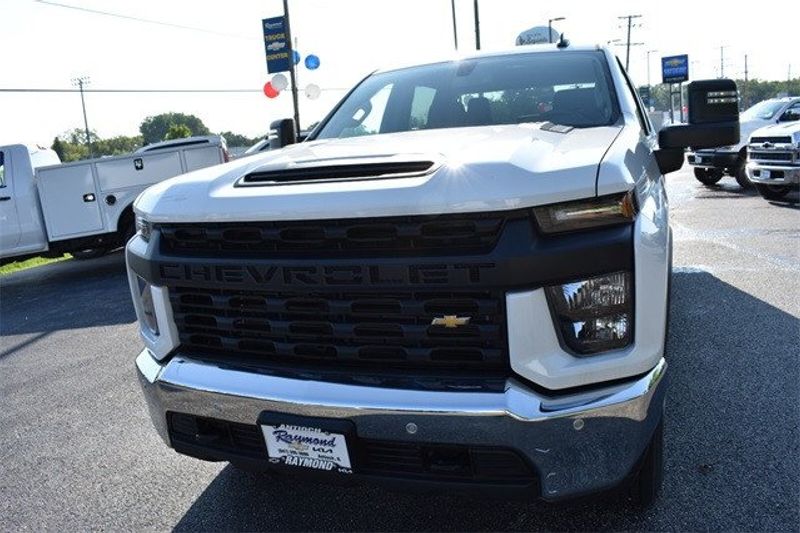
[{"xmin": 0, "ymin": 135, "xmax": 228, "ymax": 262}]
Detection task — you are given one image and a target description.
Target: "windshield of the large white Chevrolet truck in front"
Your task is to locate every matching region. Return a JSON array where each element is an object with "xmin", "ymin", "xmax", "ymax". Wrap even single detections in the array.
[{"xmin": 316, "ymin": 52, "xmax": 618, "ymax": 139}]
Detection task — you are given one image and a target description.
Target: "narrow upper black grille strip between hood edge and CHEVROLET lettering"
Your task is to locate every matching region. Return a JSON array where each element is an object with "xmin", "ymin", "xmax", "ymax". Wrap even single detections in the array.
[{"xmin": 159, "ymin": 211, "xmax": 512, "ymax": 257}]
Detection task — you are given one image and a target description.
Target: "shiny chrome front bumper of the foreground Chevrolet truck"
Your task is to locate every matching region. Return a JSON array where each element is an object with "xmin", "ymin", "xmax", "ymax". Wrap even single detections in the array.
[{"xmin": 136, "ymin": 350, "xmax": 667, "ymax": 500}]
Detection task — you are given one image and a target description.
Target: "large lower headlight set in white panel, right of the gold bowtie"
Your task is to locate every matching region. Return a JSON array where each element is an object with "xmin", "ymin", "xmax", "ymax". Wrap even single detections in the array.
[{"xmin": 545, "ymin": 272, "xmax": 633, "ymax": 355}]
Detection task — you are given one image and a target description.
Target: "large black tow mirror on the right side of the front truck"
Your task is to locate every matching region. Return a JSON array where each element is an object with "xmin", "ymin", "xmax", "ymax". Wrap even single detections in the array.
[{"xmin": 656, "ymin": 79, "xmax": 739, "ymax": 174}]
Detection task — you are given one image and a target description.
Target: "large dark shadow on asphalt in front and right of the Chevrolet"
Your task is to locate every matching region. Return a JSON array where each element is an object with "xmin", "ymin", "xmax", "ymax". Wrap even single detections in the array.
[{"xmin": 176, "ymin": 272, "xmax": 800, "ymax": 531}]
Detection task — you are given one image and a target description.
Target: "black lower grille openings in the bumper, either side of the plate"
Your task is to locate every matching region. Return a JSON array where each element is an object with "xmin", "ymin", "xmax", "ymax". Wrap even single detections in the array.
[{"xmin": 167, "ymin": 413, "xmax": 536, "ymax": 483}]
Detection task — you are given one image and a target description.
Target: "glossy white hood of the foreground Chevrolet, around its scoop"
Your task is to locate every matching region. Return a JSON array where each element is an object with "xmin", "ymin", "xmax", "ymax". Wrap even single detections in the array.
[{"xmin": 135, "ymin": 124, "xmax": 624, "ymax": 222}]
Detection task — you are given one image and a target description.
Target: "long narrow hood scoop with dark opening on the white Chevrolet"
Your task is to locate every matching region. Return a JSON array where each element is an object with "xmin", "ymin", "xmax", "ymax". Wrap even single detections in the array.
[{"xmin": 237, "ymin": 158, "xmax": 438, "ymax": 186}]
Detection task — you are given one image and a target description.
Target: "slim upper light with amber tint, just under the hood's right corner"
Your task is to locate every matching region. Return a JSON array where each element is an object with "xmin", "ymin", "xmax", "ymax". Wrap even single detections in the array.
[{"xmin": 533, "ymin": 191, "xmax": 637, "ymax": 233}]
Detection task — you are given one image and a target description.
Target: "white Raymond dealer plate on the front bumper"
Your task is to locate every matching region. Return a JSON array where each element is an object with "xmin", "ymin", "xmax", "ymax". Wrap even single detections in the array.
[{"xmin": 261, "ymin": 424, "xmax": 353, "ymax": 474}]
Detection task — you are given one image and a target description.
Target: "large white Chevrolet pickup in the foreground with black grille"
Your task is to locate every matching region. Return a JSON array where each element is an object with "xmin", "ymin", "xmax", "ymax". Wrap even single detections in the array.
[{"xmin": 126, "ymin": 41, "xmax": 739, "ymax": 506}]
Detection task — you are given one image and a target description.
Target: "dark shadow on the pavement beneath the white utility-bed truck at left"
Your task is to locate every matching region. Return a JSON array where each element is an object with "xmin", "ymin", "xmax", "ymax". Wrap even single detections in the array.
[{"xmin": 0, "ymin": 251, "xmax": 136, "ymax": 336}]
